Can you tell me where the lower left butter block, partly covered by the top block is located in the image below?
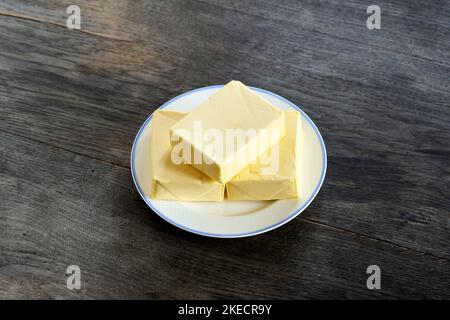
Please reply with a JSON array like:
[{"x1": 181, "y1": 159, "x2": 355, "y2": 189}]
[{"x1": 149, "y1": 110, "x2": 225, "y2": 201}]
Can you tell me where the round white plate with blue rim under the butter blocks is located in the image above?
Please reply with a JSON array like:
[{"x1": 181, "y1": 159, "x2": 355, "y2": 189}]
[{"x1": 131, "y1": 85, "x2": 327, "y2": 238}]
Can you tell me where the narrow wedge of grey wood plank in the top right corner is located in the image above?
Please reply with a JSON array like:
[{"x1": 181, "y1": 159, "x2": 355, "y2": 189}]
[{"x1": 202, "y1": 0, "x2": 450, "y2": 65}]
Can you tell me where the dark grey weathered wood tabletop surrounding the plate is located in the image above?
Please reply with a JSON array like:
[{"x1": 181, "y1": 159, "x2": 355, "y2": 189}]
[{"x1": 0, "y1": 0, "x2": 450, "y2": 299}]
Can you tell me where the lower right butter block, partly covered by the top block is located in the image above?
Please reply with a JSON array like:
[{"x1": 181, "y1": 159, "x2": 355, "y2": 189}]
[{"x1": 226, "y1": 111, "x2": 301, "y2": 200}]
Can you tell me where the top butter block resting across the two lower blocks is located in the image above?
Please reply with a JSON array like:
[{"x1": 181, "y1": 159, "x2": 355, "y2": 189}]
[{"x1": 171, "y1": 81, "x2": 284, "y2": 183}]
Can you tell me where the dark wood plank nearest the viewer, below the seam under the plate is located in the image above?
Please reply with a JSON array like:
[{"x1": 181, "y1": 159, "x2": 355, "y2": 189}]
[{"x1": 0, "y1": 133, "x2": 450, "y2": 299}]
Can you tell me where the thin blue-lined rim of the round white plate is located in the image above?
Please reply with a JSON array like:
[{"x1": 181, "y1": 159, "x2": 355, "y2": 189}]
[{"x1": 130, "y1": 85, "x2": 327, "y2": 238}]
